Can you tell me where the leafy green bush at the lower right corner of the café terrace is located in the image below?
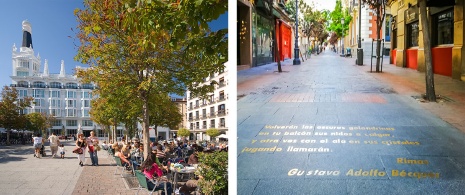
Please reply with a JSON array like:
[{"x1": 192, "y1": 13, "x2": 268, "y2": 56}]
[{"x1": 198, "y1": 151, "x2": 228, "y2": 195}]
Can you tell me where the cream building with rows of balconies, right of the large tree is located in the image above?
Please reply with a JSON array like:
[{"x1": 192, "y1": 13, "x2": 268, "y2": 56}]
[{"x1": 186, "y1": 63, "x2": 228, "y2": 140}]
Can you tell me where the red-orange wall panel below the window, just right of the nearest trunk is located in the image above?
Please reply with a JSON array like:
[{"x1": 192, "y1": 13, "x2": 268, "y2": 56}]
[{"x1": 431, "y1": 47, "x2": 452, "y2": 76}]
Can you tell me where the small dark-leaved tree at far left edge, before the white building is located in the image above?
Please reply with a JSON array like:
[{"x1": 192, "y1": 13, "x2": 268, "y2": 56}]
[{"x1": 0, "y1": 86, "x2": 33, "y2": 145}]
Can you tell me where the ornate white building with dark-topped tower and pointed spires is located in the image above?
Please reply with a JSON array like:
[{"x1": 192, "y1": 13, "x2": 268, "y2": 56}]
[{"x1": 10, "y1": 21, "x2": 116, "y2": 137}]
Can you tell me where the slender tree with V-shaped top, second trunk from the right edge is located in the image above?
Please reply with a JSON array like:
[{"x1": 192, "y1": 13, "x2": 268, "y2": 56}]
[{"x1": 362, "y1": 0, "x2": 388, "y2": 72}]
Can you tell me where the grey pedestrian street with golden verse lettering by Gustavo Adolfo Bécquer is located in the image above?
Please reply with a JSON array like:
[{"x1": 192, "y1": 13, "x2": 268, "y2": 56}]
[{"x1": 237, "y1": 51, "x2": 465, "y2": 194}]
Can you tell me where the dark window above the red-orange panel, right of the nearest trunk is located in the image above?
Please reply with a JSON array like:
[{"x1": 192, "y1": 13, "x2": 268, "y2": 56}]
[{"x1": 433, "y1": 9, "x2": 454, "y2": 45}]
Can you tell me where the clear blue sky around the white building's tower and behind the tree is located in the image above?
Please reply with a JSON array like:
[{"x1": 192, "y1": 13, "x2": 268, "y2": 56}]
[{"x1": 0, "y1": 0, "x2": 228, "y2": 88}]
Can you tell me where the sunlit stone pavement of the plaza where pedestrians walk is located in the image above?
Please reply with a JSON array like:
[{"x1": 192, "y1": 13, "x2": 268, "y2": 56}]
[{"x1": 0, "y1": 141, "x2": 136, "y2": 195}]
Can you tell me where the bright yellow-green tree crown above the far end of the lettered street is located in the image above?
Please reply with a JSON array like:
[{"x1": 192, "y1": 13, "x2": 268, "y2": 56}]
[{"x1": 328, "y1": 0, "x2": 352, "y2": 38}]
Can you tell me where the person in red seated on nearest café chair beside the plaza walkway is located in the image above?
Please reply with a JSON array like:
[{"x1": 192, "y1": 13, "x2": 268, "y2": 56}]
[{"x1": 140, "y1": 154, "x2": 173, "y2": 195}]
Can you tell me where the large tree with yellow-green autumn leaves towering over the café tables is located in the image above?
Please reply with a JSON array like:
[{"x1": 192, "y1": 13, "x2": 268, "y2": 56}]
[{"x1": 75, "y1": 0, "x2": 228, "y2": 156}]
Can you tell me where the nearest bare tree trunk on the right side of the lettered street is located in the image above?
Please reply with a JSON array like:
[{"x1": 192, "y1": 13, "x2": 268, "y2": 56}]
[{"x1": 419, "y1": 0, "x2": 436, "y2": 102}]
